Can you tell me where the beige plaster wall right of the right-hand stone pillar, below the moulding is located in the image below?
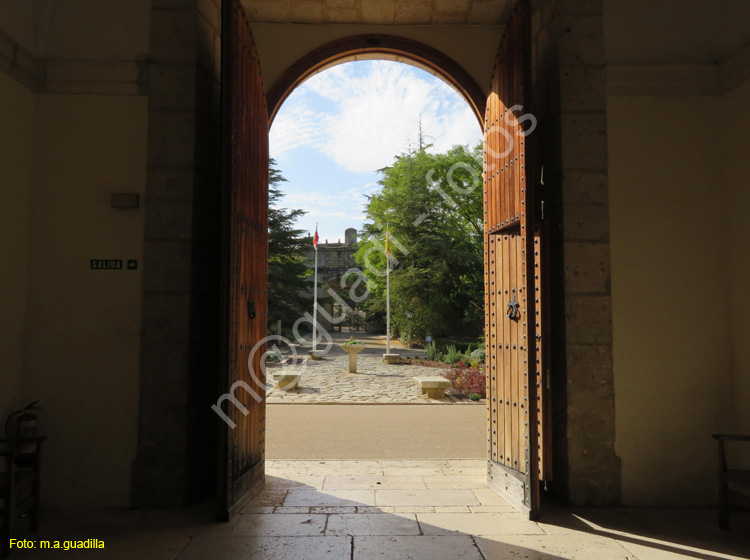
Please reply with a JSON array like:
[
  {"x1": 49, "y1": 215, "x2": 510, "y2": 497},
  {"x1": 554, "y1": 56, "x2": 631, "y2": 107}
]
[{"x1": 608, "y1": 90, "x2": 750, "y2": 505}]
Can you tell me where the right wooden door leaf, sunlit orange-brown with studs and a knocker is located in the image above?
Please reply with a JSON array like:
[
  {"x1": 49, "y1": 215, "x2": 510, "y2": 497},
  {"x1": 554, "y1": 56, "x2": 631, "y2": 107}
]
[{"x1": 484, "y1": 0, "x2": 548, "y2": 518}]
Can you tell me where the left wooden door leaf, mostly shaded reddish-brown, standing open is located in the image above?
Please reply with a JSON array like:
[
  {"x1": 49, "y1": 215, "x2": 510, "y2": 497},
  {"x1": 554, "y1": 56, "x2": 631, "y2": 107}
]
[{"x1": 218, "y1": 0, "x2": 268, "y2": 519}]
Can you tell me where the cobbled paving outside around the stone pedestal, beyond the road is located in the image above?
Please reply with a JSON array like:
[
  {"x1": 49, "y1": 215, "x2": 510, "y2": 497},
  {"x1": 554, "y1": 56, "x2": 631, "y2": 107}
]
[{"x1": 267, "y1": 332, "x2": 476, "y2": 404}]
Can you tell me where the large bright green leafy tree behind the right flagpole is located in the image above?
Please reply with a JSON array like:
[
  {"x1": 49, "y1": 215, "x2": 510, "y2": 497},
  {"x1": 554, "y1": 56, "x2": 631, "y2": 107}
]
[{"x1": 356, "y1": 145, "x2": 484, "y2": 336}]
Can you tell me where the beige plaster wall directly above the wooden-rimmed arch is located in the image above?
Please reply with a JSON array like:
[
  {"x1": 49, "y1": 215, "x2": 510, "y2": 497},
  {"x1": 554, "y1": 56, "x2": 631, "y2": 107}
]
[{"x1": 252, "y1": 23, "x2": 503, "y2": 96}]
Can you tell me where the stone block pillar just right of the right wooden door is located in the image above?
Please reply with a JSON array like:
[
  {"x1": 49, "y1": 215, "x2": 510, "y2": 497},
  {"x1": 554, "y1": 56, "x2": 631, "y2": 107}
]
[{"x1": 531, "y1": 0, "x2": 620, "y2": 505}]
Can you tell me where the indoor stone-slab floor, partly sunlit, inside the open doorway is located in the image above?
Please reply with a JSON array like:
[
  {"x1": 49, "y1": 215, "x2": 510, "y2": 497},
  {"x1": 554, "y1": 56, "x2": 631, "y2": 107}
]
[{"x1": 11, "y1": 460, "x2": 750, "y2": 560}]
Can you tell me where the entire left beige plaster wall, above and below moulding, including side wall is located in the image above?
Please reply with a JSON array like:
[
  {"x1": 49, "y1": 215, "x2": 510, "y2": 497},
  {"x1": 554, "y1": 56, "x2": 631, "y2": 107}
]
[{"x1": 0, "y1": 0, "x2": 152, "y2": 506}]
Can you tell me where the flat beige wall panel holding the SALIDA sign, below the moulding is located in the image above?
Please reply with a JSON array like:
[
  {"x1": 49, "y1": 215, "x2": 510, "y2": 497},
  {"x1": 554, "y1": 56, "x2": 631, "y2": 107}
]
[{"x1": 20, "y1": 95, "x2": 147, "y2": 506}]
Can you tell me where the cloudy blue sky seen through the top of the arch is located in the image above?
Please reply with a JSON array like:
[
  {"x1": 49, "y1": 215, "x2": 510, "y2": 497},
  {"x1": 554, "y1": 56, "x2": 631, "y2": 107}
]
[{"x1": 270, "y1": 60, "x2": 481, "y2": 243}]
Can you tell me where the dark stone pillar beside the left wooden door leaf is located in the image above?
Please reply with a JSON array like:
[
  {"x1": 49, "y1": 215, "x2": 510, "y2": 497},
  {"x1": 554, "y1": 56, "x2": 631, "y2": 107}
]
[{"x1": 133, "y1": 0, "x2": 221, "y2": 506}]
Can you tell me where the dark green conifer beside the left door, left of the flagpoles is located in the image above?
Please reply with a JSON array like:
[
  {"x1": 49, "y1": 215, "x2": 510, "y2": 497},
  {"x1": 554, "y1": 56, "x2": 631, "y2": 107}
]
[{"x1": 268, "y1": 159, "x2": 312, "y2": 328}]
